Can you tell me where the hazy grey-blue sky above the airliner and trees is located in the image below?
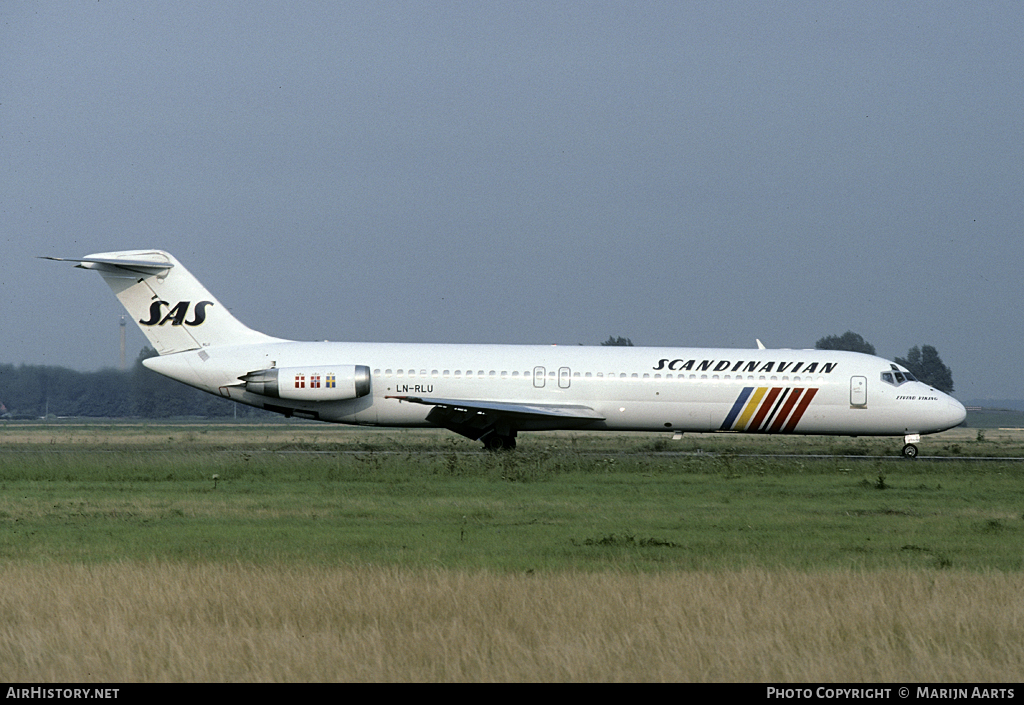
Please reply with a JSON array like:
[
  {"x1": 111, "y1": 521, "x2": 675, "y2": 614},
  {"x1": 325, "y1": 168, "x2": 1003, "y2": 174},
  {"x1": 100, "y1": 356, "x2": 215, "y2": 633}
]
[{"x1": 0, "y1": 0, "x2": 1024, "y2": 399}]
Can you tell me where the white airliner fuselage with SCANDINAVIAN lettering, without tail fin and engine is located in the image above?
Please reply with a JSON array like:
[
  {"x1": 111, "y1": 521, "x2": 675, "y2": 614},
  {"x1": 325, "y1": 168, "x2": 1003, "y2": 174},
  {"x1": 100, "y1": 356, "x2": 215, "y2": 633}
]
[{"x1": 144, "y1": 342, "x2": 965, "y2": 436}]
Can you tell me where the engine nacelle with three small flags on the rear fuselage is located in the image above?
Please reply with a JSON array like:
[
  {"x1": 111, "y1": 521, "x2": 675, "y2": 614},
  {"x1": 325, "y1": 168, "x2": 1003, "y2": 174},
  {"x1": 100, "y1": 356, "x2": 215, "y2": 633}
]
[{"x1": 239, "y1": 365, "x2": 370, "y2": 402}]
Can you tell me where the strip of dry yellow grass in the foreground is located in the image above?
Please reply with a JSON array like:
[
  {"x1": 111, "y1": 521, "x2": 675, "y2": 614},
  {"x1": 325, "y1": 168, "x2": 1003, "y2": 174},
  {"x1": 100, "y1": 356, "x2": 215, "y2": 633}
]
[{"x1": 0, "y1": 564, "x2": 1024, "y2": 682}]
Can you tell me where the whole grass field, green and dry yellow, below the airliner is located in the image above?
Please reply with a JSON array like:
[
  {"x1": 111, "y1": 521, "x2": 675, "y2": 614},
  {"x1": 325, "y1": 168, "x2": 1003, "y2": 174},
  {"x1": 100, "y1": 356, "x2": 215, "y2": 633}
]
[{"x1": 0, "y1": 423, "x2": 1024, "y2": 681}]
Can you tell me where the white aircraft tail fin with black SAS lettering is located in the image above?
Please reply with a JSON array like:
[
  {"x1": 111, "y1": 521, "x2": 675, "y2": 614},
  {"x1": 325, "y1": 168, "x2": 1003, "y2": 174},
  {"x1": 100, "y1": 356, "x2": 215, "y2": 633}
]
[{"x1": 45, "y1": 250, "x2": 276, "y2": 355}]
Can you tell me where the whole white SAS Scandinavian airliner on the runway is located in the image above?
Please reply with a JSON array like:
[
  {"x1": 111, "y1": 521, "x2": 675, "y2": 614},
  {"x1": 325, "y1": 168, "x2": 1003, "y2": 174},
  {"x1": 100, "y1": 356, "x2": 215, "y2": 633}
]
[{"x1": 48, "y1": 250, "x2": 967, "y2": 457}]
